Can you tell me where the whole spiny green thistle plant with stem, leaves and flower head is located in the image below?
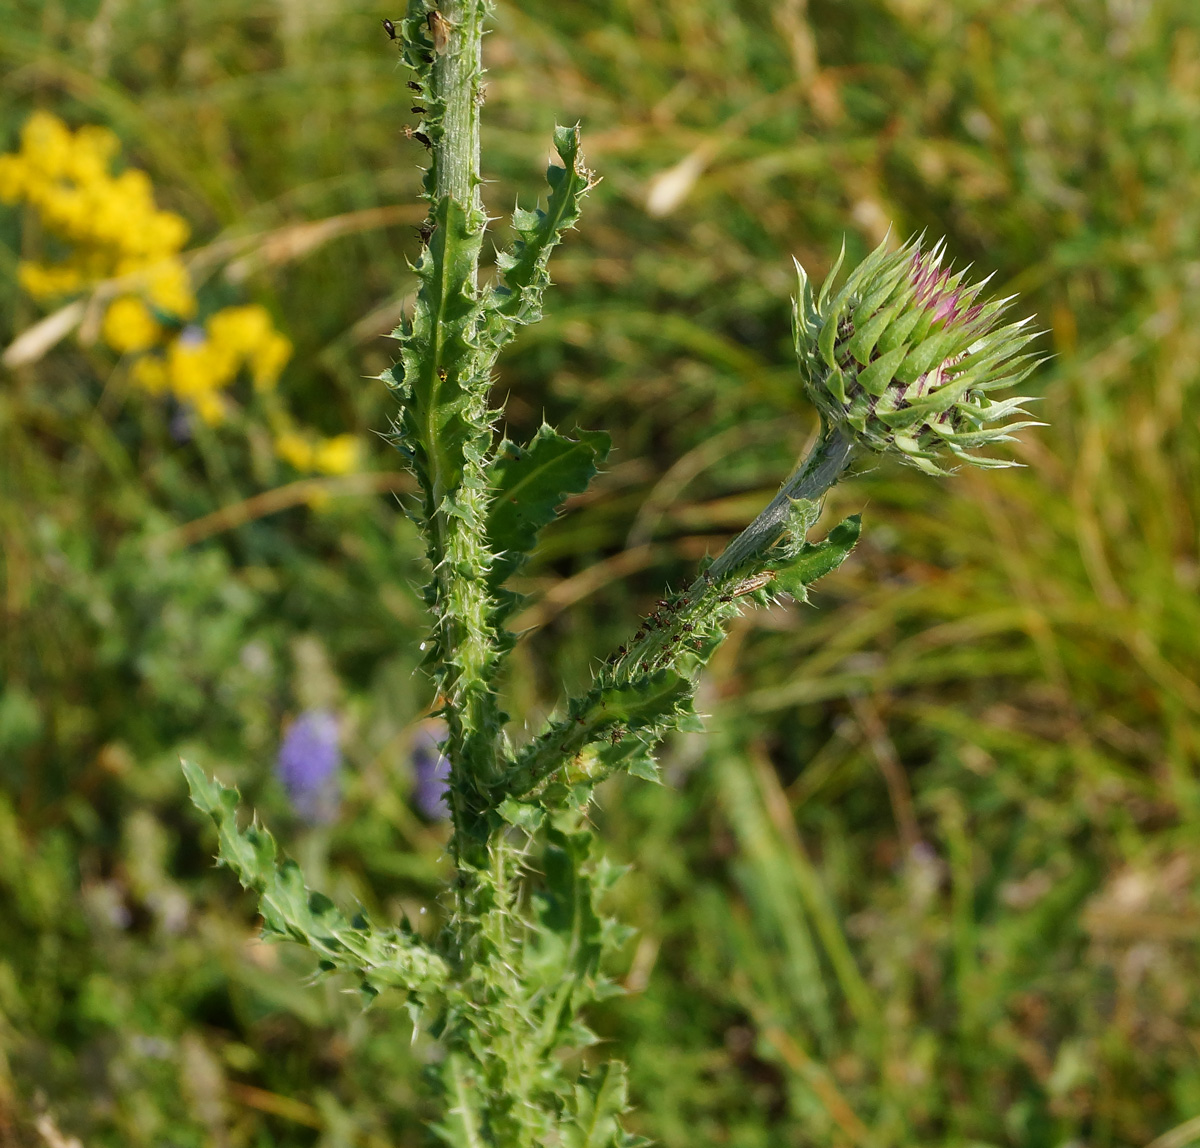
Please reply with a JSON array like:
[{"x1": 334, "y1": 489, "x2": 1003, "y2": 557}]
[{"x1": 185, "y1": 0, "x2": 1034, "y2": 1148}]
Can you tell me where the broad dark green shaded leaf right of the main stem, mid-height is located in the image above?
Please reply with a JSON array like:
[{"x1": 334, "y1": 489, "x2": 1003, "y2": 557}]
[{"x1": 487, "y1": 423, "x2": 612, "y2": 587}]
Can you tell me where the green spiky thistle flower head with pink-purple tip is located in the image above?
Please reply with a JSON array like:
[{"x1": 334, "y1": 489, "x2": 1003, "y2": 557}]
[{"x1": 793, "y1": 239, "x2": 1040, "y2": 474}]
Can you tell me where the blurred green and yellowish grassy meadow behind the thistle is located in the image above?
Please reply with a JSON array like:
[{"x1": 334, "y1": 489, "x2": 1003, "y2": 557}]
[{"x1": 0, "y1": 0, "x2": 1200, "y2": 1148}]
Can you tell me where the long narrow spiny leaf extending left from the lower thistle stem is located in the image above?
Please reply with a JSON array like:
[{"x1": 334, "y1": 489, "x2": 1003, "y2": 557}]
[{"x1": 182, "y1": 762, "x2": 449, "y2": 998}]
